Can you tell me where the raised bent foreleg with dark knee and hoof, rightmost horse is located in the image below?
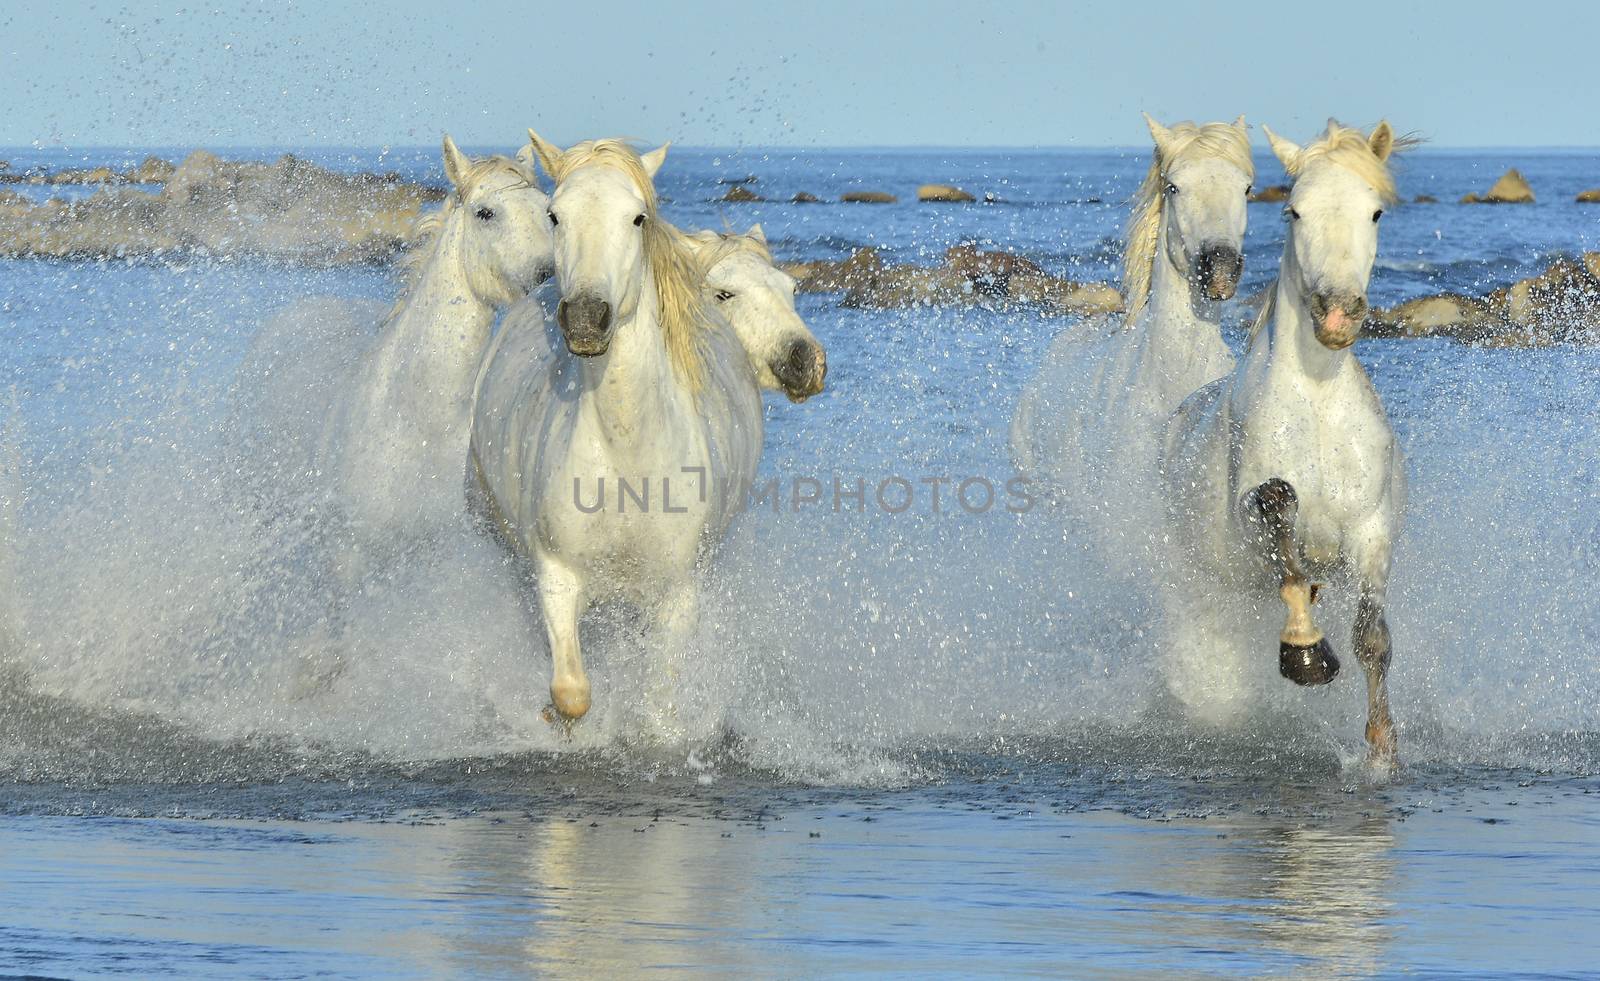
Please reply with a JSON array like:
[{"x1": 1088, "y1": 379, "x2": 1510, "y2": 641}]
[{"x1": 1245, "y1": 477, "x2": 1339, "y2": 685}]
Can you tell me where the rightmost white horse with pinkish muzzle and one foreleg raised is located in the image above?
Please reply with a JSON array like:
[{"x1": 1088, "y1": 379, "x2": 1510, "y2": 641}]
[{"x1": 1165, "y1": 120, "x2": 1405, "y2": 765}]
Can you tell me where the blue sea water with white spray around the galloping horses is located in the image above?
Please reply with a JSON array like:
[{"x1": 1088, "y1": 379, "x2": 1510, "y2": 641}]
[{"x1": 0, "y1": 146, "x2": 1600, "y2": 978}]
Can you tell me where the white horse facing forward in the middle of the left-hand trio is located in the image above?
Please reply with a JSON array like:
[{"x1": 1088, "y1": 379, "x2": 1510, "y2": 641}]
[{"x1": 472, "y1": 131, "x2": 763, "y2": 720}]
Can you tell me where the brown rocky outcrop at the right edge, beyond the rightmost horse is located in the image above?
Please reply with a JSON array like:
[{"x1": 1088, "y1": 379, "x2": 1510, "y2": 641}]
[{"x1": 1368, "y1": 253, "x2": 1600, "y2": 347}]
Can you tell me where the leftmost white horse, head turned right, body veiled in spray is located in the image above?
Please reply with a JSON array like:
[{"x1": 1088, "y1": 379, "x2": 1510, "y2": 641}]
[{"x1": 323, "y1": 136, "x2": 554, "y2": 528}]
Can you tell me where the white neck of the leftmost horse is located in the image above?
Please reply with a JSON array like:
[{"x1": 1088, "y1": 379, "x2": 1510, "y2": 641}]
[{"x1": 387, "y1": 214, "x2": 494, "y2": 384}]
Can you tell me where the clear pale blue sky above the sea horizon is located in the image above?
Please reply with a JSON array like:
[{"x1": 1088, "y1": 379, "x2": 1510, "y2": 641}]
[{"x1": 0, "y1": 0, "x2": 1600, "y2": 147}]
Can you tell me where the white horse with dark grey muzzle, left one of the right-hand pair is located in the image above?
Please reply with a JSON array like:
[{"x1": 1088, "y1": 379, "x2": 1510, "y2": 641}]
[{"x1": 1011, "y1": 115, "x2": 1254, "y2": 554}]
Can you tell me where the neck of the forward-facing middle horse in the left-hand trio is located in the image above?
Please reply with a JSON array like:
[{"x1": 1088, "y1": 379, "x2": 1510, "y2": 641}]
[{"x1": 579, "y1": 262, "x2": 682, "y2": 445}]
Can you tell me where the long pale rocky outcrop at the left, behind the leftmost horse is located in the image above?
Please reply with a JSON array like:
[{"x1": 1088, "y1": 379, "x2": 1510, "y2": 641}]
[{"x1": 0, "y1": 150, "x2": 443, "y2": 264}]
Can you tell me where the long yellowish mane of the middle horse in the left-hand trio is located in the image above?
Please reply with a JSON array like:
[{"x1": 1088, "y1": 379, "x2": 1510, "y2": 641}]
[{"x1": 547, "y1": 139, "x2": 710, "y2": 392}]
